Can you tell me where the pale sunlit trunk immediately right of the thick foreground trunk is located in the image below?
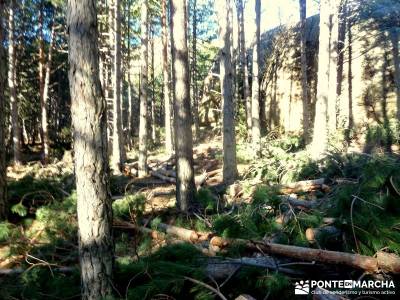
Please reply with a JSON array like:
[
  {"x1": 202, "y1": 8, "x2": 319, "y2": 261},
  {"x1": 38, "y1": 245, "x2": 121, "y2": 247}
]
[{"x1": 111, "y1": 0, "x2": 126, "y2": 173}]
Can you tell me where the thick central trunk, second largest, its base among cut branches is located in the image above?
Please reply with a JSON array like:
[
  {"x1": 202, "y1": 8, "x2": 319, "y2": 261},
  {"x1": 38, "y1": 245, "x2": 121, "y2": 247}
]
[{"x1": 170, "y1": 0, "x2": 196, "y2": 211}]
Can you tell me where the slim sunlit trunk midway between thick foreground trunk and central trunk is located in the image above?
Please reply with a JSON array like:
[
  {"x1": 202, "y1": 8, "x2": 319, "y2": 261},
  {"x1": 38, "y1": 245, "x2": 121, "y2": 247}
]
[{"x1": 139, "y1": 0, "x2": 149, "y2": 177}]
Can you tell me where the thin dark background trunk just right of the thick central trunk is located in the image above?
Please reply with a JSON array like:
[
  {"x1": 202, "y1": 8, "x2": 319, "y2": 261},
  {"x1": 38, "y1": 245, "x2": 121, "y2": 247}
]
[{"x1": 190, "y1": 0, "x2": 200, "y2": 140}]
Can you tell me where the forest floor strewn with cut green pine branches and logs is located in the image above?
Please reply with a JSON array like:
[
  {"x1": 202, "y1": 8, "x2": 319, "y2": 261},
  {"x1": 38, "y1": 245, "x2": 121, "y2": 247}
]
[{"x1": 0, "y1": 137, "x2": 400, "y2": 299}]
